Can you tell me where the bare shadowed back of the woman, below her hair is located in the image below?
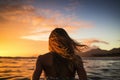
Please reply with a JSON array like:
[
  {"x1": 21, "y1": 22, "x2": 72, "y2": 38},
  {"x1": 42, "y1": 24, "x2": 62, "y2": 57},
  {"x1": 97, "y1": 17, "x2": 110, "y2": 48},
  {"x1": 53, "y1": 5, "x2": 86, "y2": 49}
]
[{"x1": 38, "y1": 52, "x2": 75, "y2": 77}]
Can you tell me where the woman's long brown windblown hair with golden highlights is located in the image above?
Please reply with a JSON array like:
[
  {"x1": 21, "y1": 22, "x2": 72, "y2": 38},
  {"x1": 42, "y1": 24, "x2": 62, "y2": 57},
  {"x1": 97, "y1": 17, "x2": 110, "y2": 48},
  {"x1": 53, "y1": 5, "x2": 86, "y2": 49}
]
[{"x1": 49, "y1": 28, "x2": 84, "y2": 73}]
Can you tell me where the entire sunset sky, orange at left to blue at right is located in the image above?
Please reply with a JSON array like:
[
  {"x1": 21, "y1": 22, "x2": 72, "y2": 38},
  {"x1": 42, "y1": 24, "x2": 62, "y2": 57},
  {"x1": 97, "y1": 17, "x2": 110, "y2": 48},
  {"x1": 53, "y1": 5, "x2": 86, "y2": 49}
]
[{"x1": 0, "y1": 0, "x2": 120, "y2": 57}]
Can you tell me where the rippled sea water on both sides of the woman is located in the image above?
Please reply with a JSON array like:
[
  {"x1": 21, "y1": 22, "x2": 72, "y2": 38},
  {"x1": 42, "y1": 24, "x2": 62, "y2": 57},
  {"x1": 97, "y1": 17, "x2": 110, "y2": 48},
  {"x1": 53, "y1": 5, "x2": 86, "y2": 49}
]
[{"x1": 0, "y1": 57, "x2": 120, "y2": 80}]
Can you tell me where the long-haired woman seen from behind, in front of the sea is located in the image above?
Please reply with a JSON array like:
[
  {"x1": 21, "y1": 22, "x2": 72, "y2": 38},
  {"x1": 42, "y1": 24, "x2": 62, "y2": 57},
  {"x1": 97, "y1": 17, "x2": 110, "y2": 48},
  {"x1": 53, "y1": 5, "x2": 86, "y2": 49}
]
[{"x1": 32, "y1": 28, "x2": 87, "y2": 80}]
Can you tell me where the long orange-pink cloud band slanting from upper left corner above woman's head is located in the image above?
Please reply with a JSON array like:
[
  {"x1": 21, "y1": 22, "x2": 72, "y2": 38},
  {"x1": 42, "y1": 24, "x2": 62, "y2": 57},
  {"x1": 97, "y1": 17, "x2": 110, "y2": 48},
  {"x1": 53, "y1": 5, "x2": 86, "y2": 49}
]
[{"x1": 0, "y1": 0, "x2": 93, "y2": 30}]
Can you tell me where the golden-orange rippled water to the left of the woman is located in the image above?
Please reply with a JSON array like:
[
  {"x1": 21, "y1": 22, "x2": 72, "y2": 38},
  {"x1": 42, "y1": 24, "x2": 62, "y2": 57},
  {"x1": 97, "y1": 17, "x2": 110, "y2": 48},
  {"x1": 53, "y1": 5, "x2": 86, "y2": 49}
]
[{"x1": 0, "y1": 59, "x2": 35, "y2": 79}]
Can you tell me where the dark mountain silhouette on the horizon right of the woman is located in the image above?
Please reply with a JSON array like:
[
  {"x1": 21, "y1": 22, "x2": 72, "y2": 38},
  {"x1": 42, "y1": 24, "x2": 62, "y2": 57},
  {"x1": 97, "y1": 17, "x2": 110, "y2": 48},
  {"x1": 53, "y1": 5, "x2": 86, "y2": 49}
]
[{"x1": 79, "y1": 48, "x2": 120, "y2": 57}]
